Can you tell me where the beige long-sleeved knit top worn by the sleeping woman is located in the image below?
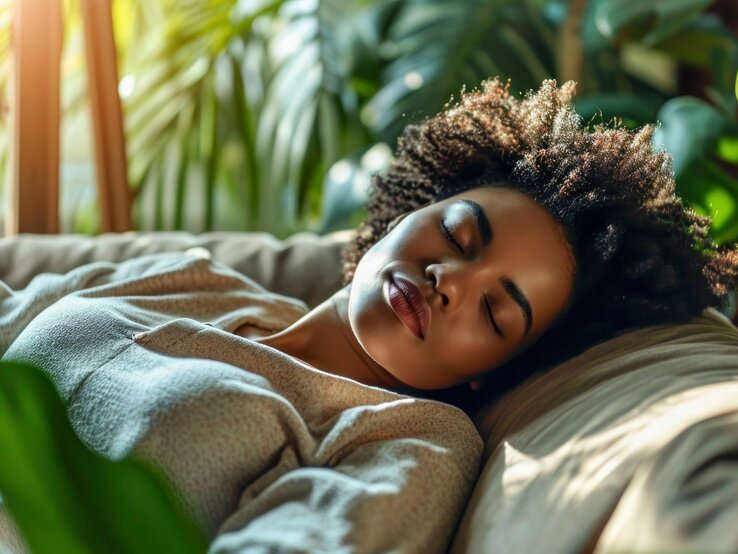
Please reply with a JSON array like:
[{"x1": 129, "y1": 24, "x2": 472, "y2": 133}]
[{"x1": 0, "y1": 249, "x2": 483, "y2": 553}]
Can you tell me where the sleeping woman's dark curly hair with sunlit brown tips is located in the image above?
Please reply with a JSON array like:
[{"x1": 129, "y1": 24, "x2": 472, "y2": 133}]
[{"x1": 343, "y1": 79, "x2": 738, "y2": 409}]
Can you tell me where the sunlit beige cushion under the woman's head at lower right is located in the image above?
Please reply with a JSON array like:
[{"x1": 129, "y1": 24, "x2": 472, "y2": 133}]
[{"x1": 452, "y1": 310, "x2": 738, "y2": 554}]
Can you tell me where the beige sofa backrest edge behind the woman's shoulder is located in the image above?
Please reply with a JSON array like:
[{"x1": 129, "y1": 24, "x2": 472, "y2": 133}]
[{"x1": 0, "y1": 230, "x2": 353, "y2": 308}]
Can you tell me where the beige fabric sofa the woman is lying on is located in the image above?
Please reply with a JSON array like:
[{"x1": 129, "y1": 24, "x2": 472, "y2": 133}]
[{"x1": 0, "y1": 231, "x2": 738, "y2": 554}]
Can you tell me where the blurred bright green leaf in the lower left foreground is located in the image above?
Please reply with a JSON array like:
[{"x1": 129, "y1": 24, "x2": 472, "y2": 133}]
[{"x1": 0, "y1": 363, "x2": 207, "y2": 554}]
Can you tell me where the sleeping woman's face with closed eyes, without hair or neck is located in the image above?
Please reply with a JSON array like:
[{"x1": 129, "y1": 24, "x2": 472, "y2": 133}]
[{"x1": 348, "y1": 187, "x2": 574, "y2": 389}]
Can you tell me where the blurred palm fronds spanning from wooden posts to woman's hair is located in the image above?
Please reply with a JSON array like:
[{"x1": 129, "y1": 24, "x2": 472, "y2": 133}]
[{"x1": 118, "y1": 0, "x2": 371, "y2": 236}]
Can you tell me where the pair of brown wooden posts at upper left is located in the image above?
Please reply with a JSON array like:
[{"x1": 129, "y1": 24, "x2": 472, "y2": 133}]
[{"x1": 5, "y1": 0, "x2": 132, "y2": 235}]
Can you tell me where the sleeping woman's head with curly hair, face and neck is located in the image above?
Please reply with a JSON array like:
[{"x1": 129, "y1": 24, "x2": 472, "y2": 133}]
[{"x1": 237, "y1": 80, "x2": 738, "y2": 411}]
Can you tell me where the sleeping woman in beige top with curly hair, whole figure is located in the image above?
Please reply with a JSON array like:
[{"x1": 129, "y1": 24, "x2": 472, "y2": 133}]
[{"x1": 0, "y1": 80, "x2": 738, "y2": 552}]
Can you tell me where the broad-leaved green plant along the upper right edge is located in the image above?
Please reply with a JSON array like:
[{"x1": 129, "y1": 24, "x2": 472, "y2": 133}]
[{"x1": 595, "y1": 0, "x2": 738, "y2": 243}]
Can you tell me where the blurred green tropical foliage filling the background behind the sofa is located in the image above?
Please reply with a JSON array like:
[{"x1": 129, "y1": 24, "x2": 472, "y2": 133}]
[{"x1": 0, "y1": 0, "x2": 738, "y2": 241}]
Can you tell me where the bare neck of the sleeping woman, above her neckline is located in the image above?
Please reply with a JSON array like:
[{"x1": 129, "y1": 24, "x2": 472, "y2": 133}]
[{"x1": 256, "y1": 285, "x2": 407, "y2": 389}]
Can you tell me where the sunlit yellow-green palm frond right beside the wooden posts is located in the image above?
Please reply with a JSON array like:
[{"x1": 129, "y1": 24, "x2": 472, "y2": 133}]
[{"x1": 123, "y1": 0, "x2": 285, "y2": 230}]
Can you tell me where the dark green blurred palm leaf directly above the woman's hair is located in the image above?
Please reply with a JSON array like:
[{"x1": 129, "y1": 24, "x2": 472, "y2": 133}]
[{"x1": 363, "y1": 0, "x2": 555, "y2": 142}]
